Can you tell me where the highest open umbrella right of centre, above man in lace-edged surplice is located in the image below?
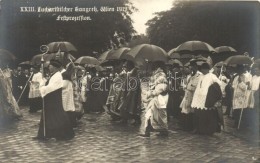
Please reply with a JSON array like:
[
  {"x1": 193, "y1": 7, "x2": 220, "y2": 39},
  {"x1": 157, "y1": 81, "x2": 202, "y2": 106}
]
[{"x1": 175, "y1": 41, "x2": 216, "y2": 54}]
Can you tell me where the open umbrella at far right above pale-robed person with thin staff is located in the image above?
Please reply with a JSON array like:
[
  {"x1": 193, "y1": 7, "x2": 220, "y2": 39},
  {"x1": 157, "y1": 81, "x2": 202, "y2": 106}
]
[{"x1": 224, "y1": 55, "x2": 253, "y2": 65}]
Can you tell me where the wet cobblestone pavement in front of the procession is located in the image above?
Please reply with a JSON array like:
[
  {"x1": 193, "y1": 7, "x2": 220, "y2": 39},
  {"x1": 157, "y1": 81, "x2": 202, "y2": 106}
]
[{"x1": 0, "y1": 108, "x2": 260, "y2": 163}]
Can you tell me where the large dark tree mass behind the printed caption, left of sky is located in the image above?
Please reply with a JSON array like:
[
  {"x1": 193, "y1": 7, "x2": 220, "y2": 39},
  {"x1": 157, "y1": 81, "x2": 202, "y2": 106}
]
[{"x1": 0, "y1": 0, "x2": 136, "y2": 61}]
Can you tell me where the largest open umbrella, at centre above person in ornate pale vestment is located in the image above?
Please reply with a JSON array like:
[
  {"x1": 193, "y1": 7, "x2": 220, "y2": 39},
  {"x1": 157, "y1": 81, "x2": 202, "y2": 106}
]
[{"x1": 123, "y1": 44, "x2": 168, "y2": 65}]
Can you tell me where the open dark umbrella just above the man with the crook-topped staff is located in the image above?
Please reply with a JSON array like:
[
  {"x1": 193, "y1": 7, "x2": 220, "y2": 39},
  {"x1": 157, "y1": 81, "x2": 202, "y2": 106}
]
[{"x1": 47, "y1": 41, "x2": 77, "y2": 53}]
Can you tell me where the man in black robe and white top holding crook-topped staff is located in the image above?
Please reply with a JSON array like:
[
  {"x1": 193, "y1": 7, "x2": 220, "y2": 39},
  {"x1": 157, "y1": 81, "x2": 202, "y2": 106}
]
[{"x1": 36, "y1": 60, "x2": 74, "y2": 140}]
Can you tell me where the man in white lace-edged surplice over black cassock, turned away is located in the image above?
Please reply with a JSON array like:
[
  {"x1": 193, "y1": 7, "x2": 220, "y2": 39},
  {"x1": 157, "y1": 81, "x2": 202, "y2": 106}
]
[{"x1": 191, "y1": 63, "x2": 222, "y2": 135}]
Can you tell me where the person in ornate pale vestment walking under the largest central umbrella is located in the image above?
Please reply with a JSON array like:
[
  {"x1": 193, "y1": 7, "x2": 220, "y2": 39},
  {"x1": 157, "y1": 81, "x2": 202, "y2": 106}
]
[{"x1": 139, "y1": 61, "x2": 169, "y2": 137}]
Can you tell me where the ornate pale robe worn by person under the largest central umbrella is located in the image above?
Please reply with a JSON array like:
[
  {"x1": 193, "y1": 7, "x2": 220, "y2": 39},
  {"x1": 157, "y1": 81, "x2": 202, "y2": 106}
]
[{"x1": 140, "y1": 68, "x2": 169, "y2": 134}]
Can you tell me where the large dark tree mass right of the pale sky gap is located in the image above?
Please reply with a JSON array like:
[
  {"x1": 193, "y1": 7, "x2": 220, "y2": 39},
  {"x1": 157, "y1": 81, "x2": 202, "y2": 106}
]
[{"x1": 147, "y1": 1, "x2": 260, "y2": 58}]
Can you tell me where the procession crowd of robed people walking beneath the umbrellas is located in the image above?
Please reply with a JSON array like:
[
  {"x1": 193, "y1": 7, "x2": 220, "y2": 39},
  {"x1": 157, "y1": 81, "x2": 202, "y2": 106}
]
[{"x1": 0, "y1": 53, "x2": 260, "y2": 140}]
